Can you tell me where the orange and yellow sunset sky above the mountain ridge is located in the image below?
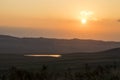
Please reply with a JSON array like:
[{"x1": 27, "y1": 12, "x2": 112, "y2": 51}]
[{"x1": 0, "y1": 0, "x2": 120, "y2": 41}]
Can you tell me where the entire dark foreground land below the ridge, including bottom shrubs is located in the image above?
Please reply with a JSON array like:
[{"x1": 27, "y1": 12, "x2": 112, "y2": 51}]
[{"x1": 0, "y1": 48, "x2": 120, "y2": 80}]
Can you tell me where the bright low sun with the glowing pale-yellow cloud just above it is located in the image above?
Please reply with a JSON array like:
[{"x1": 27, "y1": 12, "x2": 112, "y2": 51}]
[{"x1": 80, "y1": 11, "x2": 93, "y2": 24}]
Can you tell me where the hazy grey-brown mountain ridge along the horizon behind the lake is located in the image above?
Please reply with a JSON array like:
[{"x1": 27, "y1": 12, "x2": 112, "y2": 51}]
[{"x1": 0, "y1": 35, "x2": 120, "y2": 54}]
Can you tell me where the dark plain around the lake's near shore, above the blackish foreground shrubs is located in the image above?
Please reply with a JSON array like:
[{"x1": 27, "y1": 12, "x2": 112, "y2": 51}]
[{"x1": 0, "y1": 48, "x2": 120, "y2": 70}]
